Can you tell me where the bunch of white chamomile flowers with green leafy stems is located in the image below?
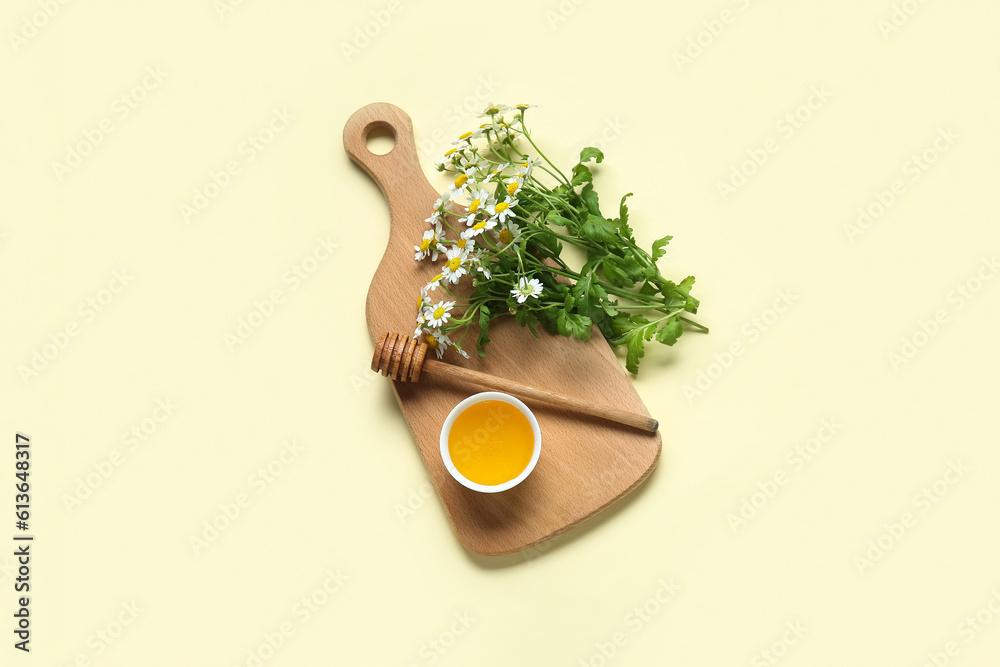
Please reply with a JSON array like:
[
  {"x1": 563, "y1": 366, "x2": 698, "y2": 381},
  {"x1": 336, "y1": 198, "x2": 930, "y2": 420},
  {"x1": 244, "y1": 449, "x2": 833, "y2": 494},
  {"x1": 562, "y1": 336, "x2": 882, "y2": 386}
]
[{"x1": 414, "y1": 104, "x2": 708, "y2": 373}]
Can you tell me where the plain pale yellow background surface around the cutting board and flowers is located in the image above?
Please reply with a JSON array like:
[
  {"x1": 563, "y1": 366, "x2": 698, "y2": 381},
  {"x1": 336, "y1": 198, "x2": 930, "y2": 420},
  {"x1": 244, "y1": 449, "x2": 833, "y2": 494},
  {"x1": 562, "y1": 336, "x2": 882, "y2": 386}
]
[{"x1": 0, "y1": 0, "x2": 1000, "y2": 666}]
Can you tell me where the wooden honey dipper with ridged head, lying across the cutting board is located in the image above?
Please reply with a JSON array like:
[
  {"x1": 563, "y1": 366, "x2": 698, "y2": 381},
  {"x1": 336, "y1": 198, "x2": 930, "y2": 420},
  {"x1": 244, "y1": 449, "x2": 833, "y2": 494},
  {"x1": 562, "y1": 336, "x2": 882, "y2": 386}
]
[{"x1": 372, "y1": 333, "x2": 660, "y2": 433}]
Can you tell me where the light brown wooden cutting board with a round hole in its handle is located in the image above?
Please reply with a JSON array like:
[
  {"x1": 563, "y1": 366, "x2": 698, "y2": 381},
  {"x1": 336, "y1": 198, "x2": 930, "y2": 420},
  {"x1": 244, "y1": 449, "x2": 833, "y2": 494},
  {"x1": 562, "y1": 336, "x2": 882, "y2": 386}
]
[{"x1": 344, "y1": 103, "x2": 660, "y2": 555}]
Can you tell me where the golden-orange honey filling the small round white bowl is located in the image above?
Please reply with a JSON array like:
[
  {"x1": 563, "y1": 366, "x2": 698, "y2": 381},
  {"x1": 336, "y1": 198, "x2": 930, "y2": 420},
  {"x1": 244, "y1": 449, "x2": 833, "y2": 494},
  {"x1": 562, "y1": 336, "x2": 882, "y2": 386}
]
[{"x1": 448, "y1": 400, "x2": 535, "y2": 486}]
